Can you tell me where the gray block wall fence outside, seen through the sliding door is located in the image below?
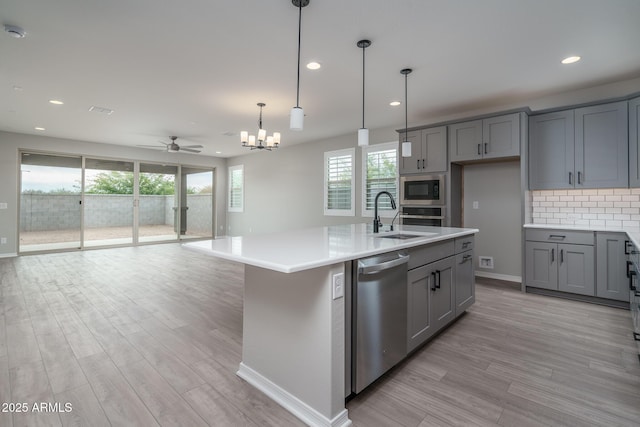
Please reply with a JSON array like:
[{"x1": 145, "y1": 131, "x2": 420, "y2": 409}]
[{"x1": 20, "y1": 194, "x2": 213, "y2": 231}]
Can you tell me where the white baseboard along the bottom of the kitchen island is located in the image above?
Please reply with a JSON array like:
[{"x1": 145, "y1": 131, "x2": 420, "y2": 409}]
[{"x1": 236, "y1": 363, "x2": 351, "y2": 427}]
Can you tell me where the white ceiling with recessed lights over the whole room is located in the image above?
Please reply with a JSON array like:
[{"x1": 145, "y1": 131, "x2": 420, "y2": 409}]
[{"x1": 0, "y1": 0, "x2": 640, "y2": 157}]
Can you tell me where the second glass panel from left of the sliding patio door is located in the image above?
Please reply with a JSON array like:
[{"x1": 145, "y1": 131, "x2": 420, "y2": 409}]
[{"x1": 84, "y1": 158, "x2": 134, "y2": 247}]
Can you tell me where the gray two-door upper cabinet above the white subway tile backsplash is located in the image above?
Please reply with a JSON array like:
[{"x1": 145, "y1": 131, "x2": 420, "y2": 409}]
[{"x1": 529, "y1": 101, "x2": 629, "y2": 190}]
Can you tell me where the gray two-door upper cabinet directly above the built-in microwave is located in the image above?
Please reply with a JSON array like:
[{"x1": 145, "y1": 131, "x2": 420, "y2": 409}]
[{"x1": 400, "y1": 126, "x2": 447, "y2": 174}]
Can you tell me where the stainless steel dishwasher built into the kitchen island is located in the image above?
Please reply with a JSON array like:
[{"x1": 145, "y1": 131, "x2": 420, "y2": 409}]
[{"x1": 351, "y1": 252, "x2": 409, "y2": 393}]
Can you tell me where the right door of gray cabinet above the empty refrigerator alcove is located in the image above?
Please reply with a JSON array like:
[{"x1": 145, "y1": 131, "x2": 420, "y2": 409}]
[{"x1": 482, "y1": 113, "x2": 520, "y2": 159}]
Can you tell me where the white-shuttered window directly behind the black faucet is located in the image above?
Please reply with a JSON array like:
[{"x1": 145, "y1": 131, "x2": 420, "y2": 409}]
[{"x1": 362, "y1": 142, "x2": 398, "y2": 216}]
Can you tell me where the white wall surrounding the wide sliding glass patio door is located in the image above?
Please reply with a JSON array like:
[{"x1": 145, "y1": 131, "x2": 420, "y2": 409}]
[{"x1": 0, "y1": 132, "x2": 227, "y2": 257}]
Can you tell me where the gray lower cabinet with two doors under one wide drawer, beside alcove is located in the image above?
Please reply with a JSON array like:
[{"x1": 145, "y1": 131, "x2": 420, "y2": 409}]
[{"x1": 525, "y1": 229, "x2": 595, "y2": 296}]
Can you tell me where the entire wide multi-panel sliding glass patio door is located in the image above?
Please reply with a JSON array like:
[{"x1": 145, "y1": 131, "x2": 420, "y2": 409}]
[{"x1": 19, "y1": 152, "x2": 215, "y2": 253}]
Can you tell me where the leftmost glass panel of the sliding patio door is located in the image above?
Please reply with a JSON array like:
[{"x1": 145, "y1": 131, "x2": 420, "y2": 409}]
[{"x1": 18, "y1": 153, "x2": 82, "y2": 252}]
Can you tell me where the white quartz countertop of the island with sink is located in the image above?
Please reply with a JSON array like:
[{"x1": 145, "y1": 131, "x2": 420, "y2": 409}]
[{"x1": 183, "y1": 224, "x2": 479, "y2": 273}]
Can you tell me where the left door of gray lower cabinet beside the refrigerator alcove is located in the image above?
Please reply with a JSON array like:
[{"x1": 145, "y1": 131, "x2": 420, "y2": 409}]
[{"x1": 525, "y1": 241, "x2": 558, "y2": 291}]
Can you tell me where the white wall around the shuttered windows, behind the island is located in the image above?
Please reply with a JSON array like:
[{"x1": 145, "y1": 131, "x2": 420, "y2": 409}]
[{"x1": 222, "y1": 128, "x2": 398, "y2": 236}]
